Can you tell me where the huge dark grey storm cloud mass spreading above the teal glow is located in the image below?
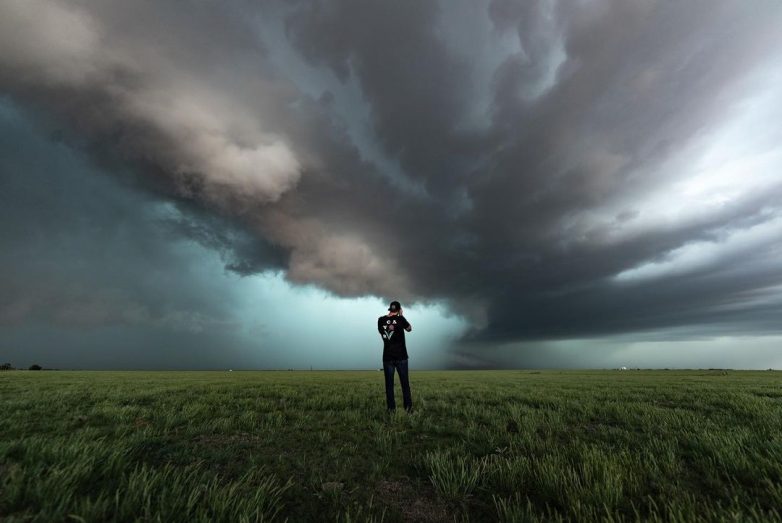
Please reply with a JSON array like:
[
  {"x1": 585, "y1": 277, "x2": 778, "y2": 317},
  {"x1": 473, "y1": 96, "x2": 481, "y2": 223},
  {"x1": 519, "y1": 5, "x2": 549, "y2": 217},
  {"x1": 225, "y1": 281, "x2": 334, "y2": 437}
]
[{"x1": 0, "y1": 0, "x2": 782, "y2": 356}]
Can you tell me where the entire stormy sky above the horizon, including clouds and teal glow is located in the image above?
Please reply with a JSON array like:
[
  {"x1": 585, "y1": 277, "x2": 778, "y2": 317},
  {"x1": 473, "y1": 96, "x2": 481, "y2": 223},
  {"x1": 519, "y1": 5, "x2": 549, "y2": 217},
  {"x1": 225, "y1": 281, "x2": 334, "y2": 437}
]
[{"x1": 0, "y1": 0, "x2": 782, "y2": 368}]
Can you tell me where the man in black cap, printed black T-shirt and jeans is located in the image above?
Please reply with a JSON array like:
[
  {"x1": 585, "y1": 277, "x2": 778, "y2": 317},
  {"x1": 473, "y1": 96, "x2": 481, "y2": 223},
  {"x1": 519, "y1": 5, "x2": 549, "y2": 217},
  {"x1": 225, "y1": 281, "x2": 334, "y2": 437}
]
[{"x1": 377, "y1": 301, "x2": 413, "y2": 412}]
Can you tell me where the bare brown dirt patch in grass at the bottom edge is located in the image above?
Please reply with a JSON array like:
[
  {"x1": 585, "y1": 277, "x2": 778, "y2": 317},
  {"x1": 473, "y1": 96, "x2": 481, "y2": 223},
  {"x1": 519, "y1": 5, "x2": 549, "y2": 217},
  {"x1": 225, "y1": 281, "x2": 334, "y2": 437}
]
[{"x1": 375, "y1": 481, "x2": 452, "y2": 523}]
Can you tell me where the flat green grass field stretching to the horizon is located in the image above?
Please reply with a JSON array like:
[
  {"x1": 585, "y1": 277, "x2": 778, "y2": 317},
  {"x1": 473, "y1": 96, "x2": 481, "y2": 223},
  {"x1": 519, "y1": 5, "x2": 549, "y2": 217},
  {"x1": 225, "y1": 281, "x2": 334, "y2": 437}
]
[{"x1": 0, "y1": 370, "x2": 782, "y2": 522}]
